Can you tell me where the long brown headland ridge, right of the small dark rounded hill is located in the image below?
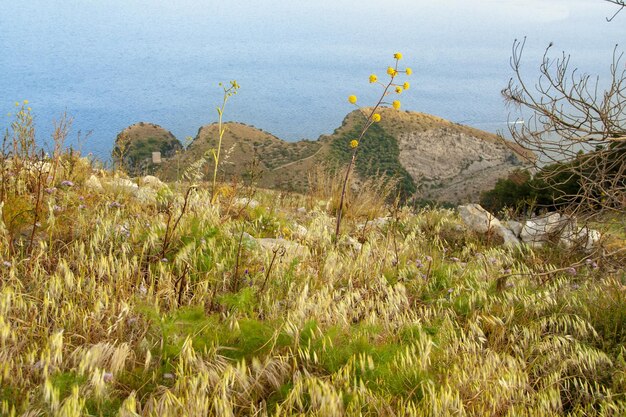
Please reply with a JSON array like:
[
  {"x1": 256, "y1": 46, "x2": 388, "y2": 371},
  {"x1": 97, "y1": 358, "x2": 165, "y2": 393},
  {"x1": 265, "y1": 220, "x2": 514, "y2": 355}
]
[{"x1": 114, "y1": 108, "x2": 533, "y2": 203}]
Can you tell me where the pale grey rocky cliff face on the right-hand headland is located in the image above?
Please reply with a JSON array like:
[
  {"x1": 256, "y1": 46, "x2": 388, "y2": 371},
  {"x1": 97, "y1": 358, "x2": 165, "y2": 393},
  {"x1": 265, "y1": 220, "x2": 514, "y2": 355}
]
[{"x1": 397, "y1": 126, "x2": 523, "y2": 203}]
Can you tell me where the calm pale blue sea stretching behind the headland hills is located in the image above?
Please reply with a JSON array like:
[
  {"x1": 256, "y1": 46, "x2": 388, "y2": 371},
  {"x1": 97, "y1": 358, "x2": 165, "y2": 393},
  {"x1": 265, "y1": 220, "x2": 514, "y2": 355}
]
[{"x1": 0, "y1": 0, "x2": 626, "y2": 159}]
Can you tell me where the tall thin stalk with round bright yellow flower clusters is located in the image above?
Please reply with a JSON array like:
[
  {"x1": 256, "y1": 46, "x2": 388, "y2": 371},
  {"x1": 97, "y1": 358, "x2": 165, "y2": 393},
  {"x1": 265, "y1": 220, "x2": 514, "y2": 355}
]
[{"x1": 335, "y1": 52, "x2": 412, "y2": 241}]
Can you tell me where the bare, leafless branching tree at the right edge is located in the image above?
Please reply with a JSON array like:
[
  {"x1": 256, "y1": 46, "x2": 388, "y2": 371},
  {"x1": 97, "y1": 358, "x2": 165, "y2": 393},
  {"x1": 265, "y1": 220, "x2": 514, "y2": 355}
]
[{"x1": 502, "y1": 29, "x2": 626, "y2": 213}]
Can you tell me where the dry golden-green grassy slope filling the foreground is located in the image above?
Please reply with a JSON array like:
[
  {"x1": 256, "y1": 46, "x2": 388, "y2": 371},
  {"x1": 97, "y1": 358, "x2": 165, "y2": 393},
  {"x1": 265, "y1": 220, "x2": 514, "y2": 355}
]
[{"x1": 0, "y1": 154, "x2": 626, "y2": 417}]
